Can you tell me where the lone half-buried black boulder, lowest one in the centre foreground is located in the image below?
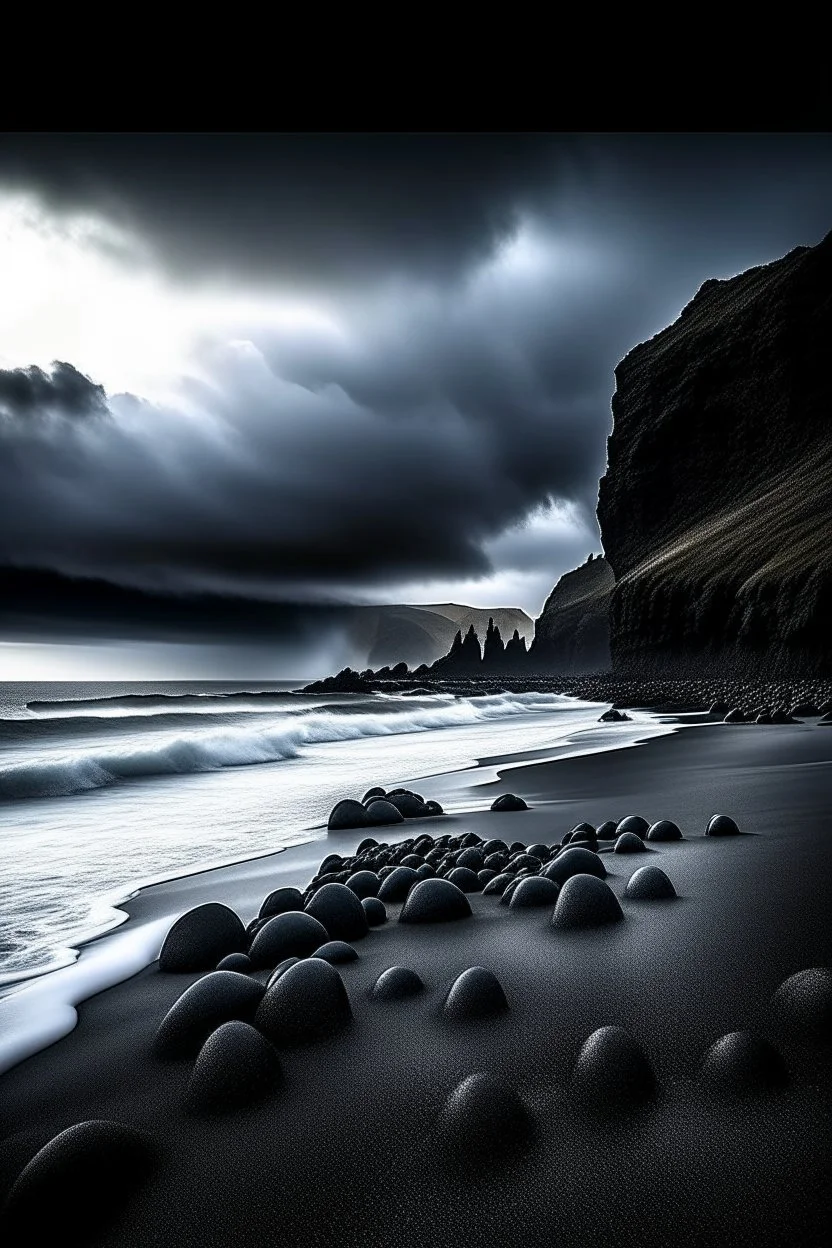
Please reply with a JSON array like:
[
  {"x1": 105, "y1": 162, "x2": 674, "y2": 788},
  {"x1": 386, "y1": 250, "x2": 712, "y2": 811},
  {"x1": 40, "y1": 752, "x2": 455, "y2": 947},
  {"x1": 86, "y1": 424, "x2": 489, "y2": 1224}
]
[{"x1": 437, "y1": 1072, "x2": 534, "y2": 1164}]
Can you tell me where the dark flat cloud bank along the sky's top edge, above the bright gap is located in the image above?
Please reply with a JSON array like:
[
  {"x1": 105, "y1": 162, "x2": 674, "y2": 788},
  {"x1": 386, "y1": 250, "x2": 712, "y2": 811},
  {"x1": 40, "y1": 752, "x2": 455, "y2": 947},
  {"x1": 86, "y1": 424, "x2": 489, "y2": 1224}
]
[{"x1": 0, "y1": 134, "x2": 580, "y2": 286}]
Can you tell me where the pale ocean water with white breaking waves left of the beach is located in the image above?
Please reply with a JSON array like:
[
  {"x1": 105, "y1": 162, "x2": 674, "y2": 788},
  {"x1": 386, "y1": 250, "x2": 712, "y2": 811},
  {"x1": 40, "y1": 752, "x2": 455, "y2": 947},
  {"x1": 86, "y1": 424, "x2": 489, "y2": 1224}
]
[{"x1": 0, "y1": 681, "x2": 667, "y2": 991}]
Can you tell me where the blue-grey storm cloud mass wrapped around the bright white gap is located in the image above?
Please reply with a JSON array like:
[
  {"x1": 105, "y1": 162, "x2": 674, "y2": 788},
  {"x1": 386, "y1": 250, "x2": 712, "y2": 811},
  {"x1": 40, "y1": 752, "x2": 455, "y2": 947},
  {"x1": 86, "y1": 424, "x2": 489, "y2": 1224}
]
[{"x1": 0, "y1": 135, "x2": 832, "y2": 635}]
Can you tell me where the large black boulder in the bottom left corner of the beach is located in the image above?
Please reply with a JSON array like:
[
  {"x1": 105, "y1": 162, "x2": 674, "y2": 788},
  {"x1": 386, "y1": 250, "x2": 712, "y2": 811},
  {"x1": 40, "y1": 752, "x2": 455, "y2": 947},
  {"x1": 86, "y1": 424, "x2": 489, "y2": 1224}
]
[{"x1": 2, "y1": 1119, "x2": 156, "y2": 1246}]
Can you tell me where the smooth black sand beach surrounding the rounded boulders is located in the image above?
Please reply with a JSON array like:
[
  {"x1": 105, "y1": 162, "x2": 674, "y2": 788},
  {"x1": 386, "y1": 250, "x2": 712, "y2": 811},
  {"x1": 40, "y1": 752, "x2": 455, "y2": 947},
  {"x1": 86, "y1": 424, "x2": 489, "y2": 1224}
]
[{"x1": 0, "y1": 723, "x2": 832, "y2": 1248}]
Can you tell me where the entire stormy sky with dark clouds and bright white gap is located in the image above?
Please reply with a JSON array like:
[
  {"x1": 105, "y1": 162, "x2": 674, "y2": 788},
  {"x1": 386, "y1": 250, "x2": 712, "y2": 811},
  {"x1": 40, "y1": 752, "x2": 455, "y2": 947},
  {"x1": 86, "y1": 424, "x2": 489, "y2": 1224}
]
[{"x1": 0, "y1": 134, "x2": 832, "y2": 679}]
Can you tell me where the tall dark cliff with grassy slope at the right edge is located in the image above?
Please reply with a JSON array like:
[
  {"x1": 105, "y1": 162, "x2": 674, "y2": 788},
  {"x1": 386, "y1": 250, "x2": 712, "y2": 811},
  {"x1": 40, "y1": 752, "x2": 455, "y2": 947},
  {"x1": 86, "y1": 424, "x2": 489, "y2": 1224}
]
[{"x1": 597, "y1": 235, "x2": 832, "y2": 678}]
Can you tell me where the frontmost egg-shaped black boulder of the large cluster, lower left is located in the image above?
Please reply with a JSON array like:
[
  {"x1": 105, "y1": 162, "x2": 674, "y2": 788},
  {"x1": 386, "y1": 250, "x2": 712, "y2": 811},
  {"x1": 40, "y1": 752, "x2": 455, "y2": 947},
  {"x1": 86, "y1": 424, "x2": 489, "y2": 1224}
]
[{"x1": 185, "y1": 1022, "x2": 282, "y2": 1113}]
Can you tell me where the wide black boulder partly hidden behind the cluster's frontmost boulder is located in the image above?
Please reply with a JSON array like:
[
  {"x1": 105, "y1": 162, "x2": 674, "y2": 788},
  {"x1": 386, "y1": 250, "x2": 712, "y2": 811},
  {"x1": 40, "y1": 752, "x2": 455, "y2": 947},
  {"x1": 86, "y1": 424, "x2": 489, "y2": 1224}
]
[{"x1": 153, "y1": 971, "x2": 264, "y2": 1057}]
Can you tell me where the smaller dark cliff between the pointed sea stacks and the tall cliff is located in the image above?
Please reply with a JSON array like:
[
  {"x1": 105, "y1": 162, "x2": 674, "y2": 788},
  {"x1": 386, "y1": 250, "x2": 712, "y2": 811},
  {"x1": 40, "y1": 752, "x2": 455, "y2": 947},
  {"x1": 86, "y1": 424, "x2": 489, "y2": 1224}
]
[{"x1": 530, "y1": 557, "x2": 614, "y2": 673}]
